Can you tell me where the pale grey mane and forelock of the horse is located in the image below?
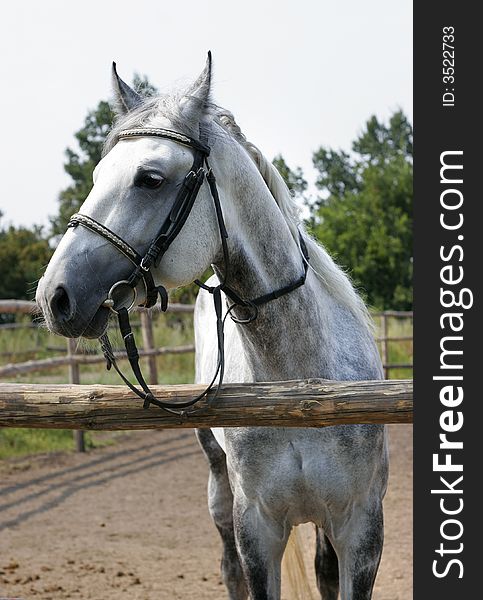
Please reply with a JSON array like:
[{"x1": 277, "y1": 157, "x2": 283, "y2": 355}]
[{"x1": 103, "y1": 94, "x2": 374, "y2": 332}]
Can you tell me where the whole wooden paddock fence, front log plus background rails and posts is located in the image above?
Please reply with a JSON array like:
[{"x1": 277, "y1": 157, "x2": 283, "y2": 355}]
[{"x1": 0, "y1": 300, "x2": 413, "y2": 452}]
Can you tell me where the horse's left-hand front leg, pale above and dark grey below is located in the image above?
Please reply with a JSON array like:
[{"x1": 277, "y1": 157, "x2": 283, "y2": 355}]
[{"x1": 233, "y1": 492, "x2": 290, "y2": 600}]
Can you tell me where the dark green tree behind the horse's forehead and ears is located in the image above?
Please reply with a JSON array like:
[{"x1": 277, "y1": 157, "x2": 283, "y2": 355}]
[{"x1": 50, "y1": 74, "x2": 156, "y2": 236}]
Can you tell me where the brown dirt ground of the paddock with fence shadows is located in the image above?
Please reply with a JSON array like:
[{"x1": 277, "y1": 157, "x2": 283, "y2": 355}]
[{"x1": 0, "y1": 425, "x2": 412, "y2": 600}]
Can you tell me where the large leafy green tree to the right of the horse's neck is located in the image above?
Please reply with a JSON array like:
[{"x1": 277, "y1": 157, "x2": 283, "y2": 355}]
[{"x1": 311, "y1": 111, "x2": 413, "y2": 310}]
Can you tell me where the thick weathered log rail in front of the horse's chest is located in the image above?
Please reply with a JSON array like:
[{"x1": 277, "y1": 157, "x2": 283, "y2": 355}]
[{"x1": 0, "y1": 379, "x2": 413, "y2": 430}]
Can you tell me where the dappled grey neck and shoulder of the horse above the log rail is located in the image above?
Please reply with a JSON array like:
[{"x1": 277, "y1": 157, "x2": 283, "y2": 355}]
[{"x1": 210, "y1": 134, "x2": 381, "y2": 381}]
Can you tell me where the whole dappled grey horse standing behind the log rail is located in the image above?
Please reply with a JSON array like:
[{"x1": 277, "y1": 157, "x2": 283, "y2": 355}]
[{"x1": 37, "y1": 57, "x2": 388, "y2": 600}]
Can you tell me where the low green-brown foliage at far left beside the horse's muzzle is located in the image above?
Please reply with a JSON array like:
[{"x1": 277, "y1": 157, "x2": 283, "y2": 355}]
[{"x1": 0, "y1": 213, "x2": 52, "y2": 300}]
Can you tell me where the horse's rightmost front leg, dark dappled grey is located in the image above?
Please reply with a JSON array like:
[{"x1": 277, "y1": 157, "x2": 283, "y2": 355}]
[{"x1": 334, "y1": 502, "x2": 384, "y2": 600}]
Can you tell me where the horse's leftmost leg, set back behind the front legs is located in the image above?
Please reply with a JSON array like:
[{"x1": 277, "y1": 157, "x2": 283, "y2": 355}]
[{"x1": 196, "y1": 429, "x2": 248, "y2": 600}]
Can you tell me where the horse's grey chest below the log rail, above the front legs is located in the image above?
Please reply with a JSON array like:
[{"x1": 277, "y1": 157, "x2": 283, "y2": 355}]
[{"x1": 218, "y1": 428, "x2": 382, "y2": 525}]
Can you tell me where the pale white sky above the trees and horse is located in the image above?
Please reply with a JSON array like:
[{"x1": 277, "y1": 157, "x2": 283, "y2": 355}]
[{"x1": 0, "y1": 0, "x2": 412, "y2": 230}]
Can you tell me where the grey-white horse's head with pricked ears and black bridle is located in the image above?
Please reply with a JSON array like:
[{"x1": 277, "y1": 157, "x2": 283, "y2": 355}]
[{"x1": 36, "y1": 54, "x2": 221, "y2": 338}]
